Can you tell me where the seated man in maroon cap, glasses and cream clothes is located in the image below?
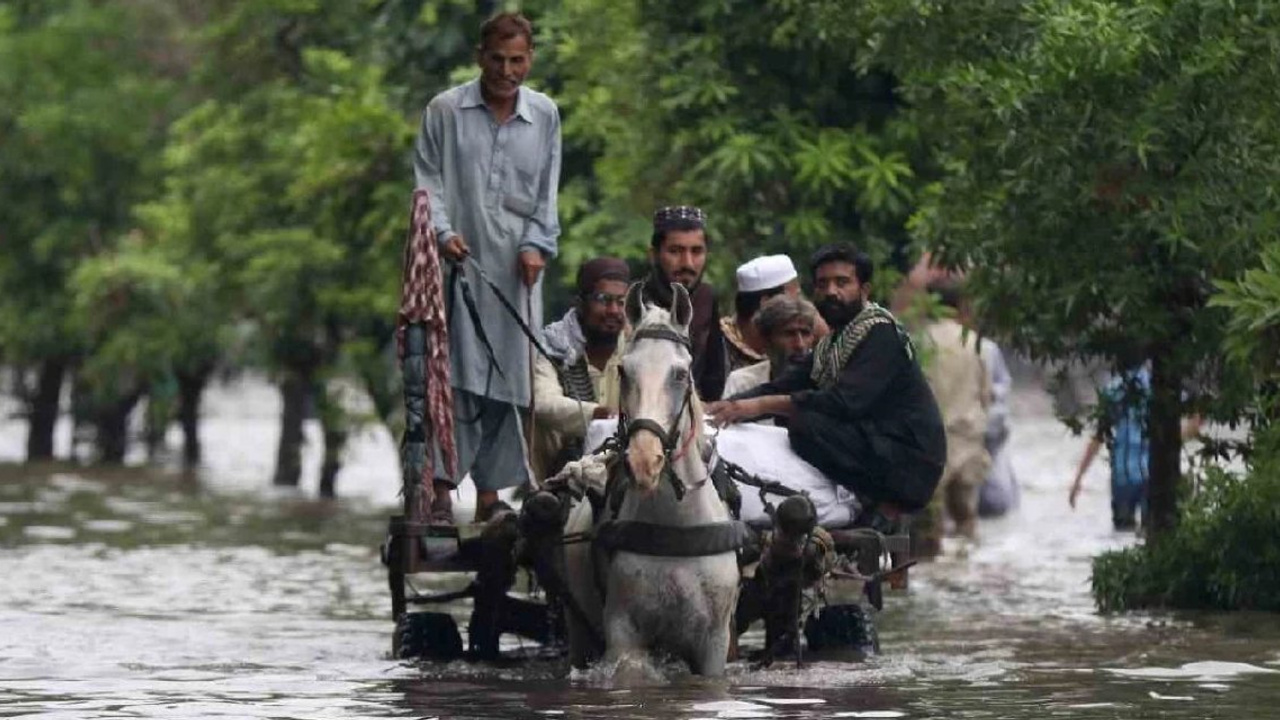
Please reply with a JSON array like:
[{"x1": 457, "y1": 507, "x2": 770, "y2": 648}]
[{"x1": 530, "y1": 258, "x2": 631, "y2": 478}]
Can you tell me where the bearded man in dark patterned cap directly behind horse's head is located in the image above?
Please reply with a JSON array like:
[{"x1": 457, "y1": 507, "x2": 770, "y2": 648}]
[{"x1": 644, "y1": 205, "x2": 728, "y2": 400}]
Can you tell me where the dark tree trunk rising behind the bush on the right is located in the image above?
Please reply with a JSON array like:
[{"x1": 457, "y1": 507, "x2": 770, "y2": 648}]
[{"x1": 1147, "y1": 352, "x2": 1183, "y2": 539}]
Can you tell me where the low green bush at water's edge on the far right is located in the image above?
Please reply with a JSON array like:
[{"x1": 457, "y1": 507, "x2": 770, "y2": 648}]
[{"x1": 1093, "y1": 454, "x2": 1280, "y2": 612}]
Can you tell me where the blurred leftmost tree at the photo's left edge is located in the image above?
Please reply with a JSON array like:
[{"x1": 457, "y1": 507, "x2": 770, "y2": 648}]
[{"x1": 0, "y1": 0, "x2": 185, "y2": 460}]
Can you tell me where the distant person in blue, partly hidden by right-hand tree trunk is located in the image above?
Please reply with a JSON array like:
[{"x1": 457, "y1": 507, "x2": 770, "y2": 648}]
[{"x1": 1069, "y1": 365, "x2": 1201, "y2": 530}]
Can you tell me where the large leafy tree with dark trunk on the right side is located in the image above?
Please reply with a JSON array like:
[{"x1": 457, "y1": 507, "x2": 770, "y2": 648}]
[{"x1": 849, "y1": 0, "x2": 1280, "y2": 537}]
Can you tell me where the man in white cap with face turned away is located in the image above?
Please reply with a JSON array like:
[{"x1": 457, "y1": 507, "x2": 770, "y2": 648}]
[{"x1": 721, "y1": 255, "x2": 800, "y2": 373}]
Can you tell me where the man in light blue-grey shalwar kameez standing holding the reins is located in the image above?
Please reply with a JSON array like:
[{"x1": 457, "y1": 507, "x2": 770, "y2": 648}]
[{"x1": 413, "y1": 13, "x2": 561, "y2": 523}]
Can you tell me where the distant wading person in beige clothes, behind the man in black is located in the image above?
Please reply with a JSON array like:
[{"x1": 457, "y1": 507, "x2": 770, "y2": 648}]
[{"x1": 924, "y1": 281, "x2": 992, "y2": 539}]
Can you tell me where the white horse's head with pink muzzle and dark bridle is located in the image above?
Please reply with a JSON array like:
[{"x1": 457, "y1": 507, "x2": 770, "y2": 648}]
[{"x1": 618, "y1": 283, "x2": 701, "y2": 493}]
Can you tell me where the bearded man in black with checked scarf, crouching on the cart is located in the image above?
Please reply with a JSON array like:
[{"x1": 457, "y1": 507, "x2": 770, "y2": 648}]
[{"x1": 708, "y1": 243, "x2": 947, "y2": 533}]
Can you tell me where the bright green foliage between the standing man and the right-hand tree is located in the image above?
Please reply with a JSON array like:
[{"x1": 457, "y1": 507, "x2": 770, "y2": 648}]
[{"x1": 543, "y1": 0, "x2": 916, "y2": 293}]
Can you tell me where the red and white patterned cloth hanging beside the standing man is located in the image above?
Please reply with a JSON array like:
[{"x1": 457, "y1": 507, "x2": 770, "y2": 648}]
[{"x1": 396, "y1": 190, "x2": 458, "y2": 507}]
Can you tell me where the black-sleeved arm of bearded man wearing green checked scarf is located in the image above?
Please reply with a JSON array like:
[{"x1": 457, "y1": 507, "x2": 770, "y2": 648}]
[{"x1": 791, "y1": 323, "x2": 911, "y2": 420}]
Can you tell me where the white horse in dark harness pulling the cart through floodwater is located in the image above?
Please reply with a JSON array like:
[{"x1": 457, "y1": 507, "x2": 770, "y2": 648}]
[{"x1": 564, "y1": 284, "x2": 741, "y2": 675}]
